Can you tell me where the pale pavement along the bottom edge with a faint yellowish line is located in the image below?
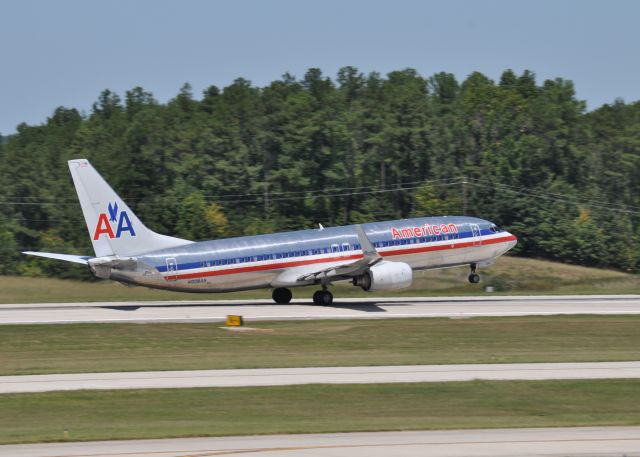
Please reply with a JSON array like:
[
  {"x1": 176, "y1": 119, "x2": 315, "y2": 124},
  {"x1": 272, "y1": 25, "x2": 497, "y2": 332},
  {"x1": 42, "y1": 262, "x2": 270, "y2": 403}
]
[{"x1": 0, "y1": 427, "x2": 640, "y2": 457}]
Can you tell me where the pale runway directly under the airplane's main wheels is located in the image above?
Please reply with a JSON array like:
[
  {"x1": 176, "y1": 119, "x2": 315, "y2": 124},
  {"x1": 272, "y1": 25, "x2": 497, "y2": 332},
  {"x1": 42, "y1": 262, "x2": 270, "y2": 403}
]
[{"x1": 0, "y1": 295, "x2": 640, "y2": 324}]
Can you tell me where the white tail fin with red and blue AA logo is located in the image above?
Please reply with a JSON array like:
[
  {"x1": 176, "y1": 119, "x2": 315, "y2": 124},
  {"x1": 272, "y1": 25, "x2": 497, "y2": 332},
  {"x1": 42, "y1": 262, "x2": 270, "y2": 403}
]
[{"x1": 69, "y1": 159, "x2": 191, "y2": 257}]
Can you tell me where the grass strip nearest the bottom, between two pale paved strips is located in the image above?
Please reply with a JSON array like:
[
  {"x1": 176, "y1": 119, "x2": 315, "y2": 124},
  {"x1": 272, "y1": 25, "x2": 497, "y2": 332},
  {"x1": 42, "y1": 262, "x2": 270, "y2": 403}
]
[{"x1": 0, "y1": 380, "x2": 640, "y2": 444}]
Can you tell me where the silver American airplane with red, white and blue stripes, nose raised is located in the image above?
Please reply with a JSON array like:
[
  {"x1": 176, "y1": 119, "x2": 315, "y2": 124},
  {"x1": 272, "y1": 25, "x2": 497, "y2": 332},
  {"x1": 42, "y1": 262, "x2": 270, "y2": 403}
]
[{"x1": 23, "y1": 159, "x2": 517, "y2": 306}]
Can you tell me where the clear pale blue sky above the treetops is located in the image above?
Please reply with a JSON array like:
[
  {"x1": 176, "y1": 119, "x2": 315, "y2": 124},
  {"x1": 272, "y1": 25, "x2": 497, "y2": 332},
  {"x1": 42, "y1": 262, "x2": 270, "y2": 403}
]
[{"x1": 0, "y1": 0, "x2": 640, "y2": 135}]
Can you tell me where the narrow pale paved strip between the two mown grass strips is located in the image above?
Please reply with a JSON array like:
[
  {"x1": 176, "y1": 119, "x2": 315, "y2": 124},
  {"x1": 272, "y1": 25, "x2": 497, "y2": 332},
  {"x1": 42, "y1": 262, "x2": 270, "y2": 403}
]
[{"x1": 0, "y1": 362, "x2": 640, "y2": 394}]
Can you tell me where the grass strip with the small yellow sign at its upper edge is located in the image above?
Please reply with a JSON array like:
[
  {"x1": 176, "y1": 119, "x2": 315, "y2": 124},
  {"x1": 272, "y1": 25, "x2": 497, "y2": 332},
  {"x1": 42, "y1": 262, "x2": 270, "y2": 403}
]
[{"x1": 0, "y1": 316, "x2": 640, "y2": 375}]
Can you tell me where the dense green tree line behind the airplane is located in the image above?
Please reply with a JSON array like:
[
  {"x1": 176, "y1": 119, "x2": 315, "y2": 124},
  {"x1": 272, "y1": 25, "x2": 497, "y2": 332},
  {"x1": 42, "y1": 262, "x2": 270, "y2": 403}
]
[{"x1": 0, "y1": 67, "x2": 640, "y2": 277}]
